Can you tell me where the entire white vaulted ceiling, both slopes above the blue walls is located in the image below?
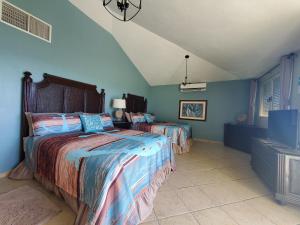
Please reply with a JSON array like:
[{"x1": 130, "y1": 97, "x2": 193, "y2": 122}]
[{"x1": 70, "y1": 0, "x2": 300, "y2": 85}]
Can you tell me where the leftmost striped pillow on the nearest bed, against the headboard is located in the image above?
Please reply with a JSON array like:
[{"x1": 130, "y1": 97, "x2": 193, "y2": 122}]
[{"x1": 26, "y1": 113, "x2": 82, "y2": 136}]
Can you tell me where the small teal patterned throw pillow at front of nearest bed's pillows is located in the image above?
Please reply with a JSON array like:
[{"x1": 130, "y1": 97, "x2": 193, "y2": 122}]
[{"x1": 80, "y1": 114, "x2": 103, "y2": 133}]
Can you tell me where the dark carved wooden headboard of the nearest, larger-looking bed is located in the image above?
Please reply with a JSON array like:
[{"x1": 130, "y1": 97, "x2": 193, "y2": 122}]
[{"x1": 21, "y1": 72, "x2": 105, "y2": 140}]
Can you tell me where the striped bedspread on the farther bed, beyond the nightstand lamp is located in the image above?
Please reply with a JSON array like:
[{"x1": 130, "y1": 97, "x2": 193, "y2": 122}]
[{"x1": 132, "y1": 123, "x2": 192, "y2": 151}]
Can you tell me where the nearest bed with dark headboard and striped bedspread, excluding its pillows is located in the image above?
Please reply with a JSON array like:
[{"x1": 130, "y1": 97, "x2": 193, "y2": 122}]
[{"x1": 10, "y1": 73, "x2": 175, "y2": 225}]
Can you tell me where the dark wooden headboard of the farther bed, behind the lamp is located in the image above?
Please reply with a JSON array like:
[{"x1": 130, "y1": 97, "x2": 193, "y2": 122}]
[{"x1": 123, "y1": 94, "x2": 147, "y2": 113}]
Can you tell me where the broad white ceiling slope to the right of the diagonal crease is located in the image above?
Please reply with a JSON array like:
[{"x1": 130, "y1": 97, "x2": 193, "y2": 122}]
[{"x1": 134, "y1": 0, "x2": 300, "y2": 78}]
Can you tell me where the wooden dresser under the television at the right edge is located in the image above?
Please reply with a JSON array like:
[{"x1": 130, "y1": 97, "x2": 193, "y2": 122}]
[{"x1": 251, "y1": 138, "x2": 300, "y2": 205}]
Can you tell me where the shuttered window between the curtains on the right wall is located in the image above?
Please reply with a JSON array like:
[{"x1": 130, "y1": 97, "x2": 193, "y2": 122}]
[{"x1": 260, "y1": 73, "x2": 280, "y2": 117}]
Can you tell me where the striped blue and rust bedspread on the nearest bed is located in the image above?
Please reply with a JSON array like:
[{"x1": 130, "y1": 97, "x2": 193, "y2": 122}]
[{"x1": 25, "y1": 130, "x2": 174, "y2": 225}]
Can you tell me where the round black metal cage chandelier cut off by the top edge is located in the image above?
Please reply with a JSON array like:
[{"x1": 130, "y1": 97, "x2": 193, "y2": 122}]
[{"x1": 103, "y1": 0, "x2": 142, "y2": 22}]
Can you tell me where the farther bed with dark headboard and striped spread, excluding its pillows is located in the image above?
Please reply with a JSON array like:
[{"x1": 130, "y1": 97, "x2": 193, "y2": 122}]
[{"x1": 123, "y1": 93, "x2": 192, "y2": 154}]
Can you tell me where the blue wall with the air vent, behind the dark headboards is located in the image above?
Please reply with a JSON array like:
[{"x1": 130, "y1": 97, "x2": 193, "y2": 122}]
[{"x1": 0, "y1": 0, "x2": 149, "y2": 173}]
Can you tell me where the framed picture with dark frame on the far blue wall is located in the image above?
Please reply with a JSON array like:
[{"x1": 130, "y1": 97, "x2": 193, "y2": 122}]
[{"x1": 179, "y1": 100, "x2": 207, "y2": 121}]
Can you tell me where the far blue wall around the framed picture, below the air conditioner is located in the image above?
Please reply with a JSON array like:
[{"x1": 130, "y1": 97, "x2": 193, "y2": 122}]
[{"x1": 149, "y1": 80, "x2": 250, "y2": 141}]
